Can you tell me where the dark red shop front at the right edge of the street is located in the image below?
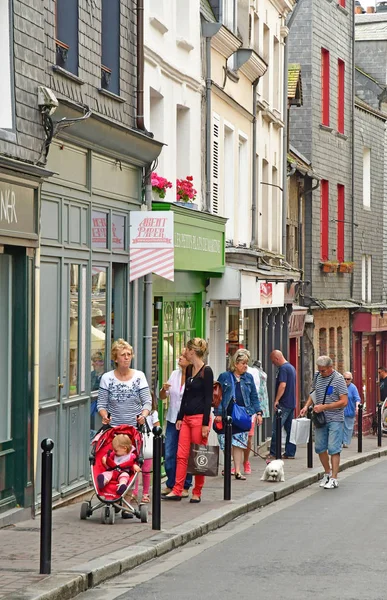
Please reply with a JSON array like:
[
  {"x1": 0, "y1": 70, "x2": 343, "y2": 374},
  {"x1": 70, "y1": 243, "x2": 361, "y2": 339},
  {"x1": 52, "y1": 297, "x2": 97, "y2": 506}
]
[{"x1": 352, "y1": 311, "x2": 387, "y2": 431}]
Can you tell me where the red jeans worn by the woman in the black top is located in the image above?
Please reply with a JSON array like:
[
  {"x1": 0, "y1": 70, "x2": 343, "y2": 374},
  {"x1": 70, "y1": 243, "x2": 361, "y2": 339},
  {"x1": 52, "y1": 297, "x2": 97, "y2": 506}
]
[{"x1": 173, "y1": 415, "x2": 210, "y2": 498}]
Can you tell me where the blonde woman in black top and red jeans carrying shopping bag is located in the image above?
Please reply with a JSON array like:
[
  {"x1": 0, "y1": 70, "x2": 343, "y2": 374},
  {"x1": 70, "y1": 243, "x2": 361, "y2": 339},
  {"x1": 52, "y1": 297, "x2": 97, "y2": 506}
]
[{"x1": 163, "y1": 338, "x2": 214, "y2": 504}]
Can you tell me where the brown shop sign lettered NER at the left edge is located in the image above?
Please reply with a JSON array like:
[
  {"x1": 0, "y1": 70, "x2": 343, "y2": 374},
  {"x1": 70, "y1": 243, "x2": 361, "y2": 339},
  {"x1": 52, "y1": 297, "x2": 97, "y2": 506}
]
[{"x1": 0, "y1": 181, "x2": 37, "y2": 237}]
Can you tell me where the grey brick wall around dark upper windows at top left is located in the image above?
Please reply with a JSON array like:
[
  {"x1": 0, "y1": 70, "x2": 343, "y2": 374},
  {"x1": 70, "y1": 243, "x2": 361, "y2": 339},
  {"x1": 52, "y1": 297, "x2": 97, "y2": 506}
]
[{"x1": 0, "y1": 0, "x2": 137, "y2": 162}]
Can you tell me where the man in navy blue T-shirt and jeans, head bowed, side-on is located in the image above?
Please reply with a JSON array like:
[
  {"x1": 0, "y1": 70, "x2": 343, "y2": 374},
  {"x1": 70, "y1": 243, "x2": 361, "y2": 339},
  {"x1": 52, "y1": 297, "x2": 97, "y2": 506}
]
[{"x1": 268, "y1": 350, "x2": 297, "y2": 460}]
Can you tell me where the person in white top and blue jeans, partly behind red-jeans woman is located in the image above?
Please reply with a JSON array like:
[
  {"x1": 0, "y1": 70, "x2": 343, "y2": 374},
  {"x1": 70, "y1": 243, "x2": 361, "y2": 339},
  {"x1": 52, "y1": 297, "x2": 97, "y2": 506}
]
[{"x1": 160, "y1": 348, "x2": 192, "y2": 498}]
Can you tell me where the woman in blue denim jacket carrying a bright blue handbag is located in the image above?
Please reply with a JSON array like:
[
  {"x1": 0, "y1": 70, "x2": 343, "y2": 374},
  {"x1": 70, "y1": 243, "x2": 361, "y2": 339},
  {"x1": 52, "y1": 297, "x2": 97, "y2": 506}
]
[{"x1": 214, "y1": 349, "x2": 262, "y2": 480}]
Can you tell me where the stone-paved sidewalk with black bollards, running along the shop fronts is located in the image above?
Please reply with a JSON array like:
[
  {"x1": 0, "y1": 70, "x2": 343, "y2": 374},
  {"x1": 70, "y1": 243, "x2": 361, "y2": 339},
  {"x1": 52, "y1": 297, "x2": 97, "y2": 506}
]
[{"x1": 0, "y1": 436, "x2": 387, "y2": 600}]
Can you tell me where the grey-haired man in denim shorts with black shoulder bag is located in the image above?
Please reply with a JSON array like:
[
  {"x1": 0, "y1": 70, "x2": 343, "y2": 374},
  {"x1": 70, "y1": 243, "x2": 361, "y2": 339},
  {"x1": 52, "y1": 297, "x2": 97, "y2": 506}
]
[{"x1": 300, "y1": 356, "x2": 348, "y2": 490}]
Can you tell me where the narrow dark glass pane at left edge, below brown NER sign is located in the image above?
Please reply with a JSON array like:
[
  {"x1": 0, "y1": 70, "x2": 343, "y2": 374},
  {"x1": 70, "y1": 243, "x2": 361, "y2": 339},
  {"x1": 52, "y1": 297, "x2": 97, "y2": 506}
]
[{"x1": 0, "y1": 254, "x2": 12, "y2": 442}]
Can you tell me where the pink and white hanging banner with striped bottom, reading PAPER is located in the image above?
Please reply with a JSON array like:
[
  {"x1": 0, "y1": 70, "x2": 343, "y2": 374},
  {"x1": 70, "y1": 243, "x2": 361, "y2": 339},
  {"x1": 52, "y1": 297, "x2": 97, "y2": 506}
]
[{"x1": 129, "y1": 211, "x2": 175, "y2": 281}]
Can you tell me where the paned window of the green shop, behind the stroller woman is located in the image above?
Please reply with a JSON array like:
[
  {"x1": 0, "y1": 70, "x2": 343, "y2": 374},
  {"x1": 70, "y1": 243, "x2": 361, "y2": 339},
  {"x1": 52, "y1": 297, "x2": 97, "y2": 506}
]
[{"x1": 162, "y1": 300, "x2": 197, "y2": 381}]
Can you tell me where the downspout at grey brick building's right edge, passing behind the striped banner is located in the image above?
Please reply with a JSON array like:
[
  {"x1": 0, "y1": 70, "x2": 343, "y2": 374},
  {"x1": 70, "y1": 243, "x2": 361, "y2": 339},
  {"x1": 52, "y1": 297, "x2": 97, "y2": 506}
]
[{"x1": 135, "y1": 0, "x2": 153, "y2": 387}]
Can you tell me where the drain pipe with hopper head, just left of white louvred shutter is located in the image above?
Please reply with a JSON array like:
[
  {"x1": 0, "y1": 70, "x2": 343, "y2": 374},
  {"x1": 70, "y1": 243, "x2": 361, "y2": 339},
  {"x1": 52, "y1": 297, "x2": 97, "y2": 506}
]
[{"x1": 202, "y1": 21, "x2": 222, "y2": 212}]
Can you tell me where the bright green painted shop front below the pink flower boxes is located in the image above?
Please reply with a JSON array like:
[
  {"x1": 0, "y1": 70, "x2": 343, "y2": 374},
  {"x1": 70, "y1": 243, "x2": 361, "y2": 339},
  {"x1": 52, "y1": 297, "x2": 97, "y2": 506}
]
[{"x1": 153, "y1": 202, "x2": 226, "y2": 422}]
